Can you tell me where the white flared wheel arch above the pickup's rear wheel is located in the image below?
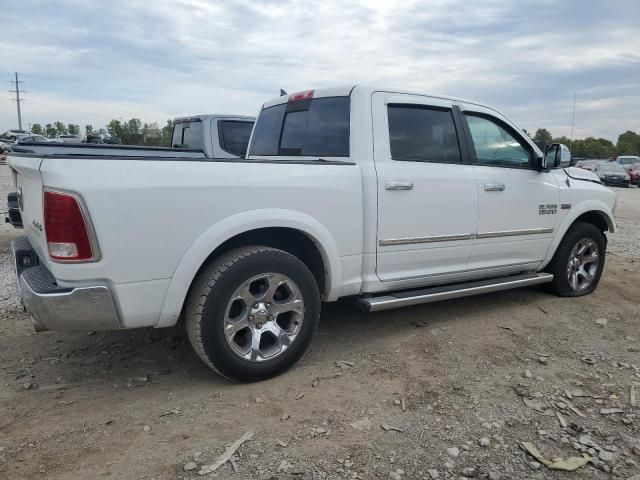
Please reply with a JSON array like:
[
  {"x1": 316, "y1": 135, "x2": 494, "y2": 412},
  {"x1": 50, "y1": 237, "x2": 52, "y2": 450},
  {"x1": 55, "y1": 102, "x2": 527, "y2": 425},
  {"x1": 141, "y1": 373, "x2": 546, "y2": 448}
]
[{"x1": 156, "y1": 209, "x2": 342, "y2": 328}]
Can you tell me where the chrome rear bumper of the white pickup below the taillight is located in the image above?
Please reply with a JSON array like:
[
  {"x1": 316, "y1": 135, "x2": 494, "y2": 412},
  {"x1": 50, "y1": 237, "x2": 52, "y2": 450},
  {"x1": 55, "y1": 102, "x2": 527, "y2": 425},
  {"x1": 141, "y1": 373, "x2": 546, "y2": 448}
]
[{"x1": 11, "y1": 237, "x2": 120, "y2": 332}]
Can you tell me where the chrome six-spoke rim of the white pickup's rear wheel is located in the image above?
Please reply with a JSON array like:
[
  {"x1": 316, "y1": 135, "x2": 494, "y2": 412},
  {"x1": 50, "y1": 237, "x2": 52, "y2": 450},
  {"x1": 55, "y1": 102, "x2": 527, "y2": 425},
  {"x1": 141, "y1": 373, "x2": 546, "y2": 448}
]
[{"x1": 224, "y1": 273, "x2": 304, "y2": 362}]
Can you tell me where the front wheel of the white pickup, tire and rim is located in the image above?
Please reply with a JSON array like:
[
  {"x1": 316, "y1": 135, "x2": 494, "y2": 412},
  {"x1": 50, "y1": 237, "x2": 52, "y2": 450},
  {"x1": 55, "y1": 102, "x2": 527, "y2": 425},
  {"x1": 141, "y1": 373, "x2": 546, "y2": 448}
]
[{"x1": 547, "y1": 222, "x2": 606, "y2": 297}]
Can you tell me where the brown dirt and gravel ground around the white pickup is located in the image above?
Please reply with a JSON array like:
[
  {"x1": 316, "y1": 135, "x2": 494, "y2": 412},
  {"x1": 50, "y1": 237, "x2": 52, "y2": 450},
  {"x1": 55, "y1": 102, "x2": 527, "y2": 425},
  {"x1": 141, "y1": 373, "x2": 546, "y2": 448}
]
[{"x1": 0, "y1": 171, "x2": 640, "y2": 479}]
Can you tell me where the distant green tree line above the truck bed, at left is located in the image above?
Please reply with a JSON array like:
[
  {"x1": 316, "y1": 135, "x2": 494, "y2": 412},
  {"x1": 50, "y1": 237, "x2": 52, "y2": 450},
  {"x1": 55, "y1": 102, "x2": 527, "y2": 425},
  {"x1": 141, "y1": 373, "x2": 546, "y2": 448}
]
[{"x1": 31, "y1": 118, "x2": 173, "y2": 147}]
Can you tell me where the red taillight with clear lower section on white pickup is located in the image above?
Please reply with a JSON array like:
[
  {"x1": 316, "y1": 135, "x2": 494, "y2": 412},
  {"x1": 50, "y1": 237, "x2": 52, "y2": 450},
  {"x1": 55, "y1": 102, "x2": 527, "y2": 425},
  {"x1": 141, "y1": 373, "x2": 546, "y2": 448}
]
[{"x1": 44, "y1": 191, "x2": 93, "y2": 261}]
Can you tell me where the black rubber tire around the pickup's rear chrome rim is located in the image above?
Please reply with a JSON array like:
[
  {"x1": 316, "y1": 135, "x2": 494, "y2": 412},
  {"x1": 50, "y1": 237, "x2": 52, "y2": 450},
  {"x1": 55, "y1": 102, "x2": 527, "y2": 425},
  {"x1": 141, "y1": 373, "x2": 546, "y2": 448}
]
[{"x1": 185, "y1": 246, "x2": 320, "y2": 382}]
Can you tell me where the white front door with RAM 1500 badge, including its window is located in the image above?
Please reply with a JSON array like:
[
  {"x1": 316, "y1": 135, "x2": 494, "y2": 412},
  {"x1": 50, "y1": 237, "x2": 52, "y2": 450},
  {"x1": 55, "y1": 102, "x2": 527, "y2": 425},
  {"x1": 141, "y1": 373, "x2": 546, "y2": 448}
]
[{"x1": 463, "y1": 106, "x2": 560, "y2": 271}]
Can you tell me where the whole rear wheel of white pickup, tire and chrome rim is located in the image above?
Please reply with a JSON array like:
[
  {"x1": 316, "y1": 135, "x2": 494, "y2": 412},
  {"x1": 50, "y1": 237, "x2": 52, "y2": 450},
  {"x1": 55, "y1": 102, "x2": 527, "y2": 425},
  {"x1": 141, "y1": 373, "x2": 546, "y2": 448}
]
[{"x1": 185, "y1": 246, "x2": 320, "y2": 381}]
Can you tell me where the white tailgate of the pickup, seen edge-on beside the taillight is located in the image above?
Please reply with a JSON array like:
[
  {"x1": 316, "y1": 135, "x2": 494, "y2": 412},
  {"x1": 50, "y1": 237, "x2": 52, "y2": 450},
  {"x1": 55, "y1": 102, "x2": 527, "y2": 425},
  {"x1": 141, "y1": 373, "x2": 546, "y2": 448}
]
[{"x1": 7, "y1": 155, "x2": 48, "y2": 263}]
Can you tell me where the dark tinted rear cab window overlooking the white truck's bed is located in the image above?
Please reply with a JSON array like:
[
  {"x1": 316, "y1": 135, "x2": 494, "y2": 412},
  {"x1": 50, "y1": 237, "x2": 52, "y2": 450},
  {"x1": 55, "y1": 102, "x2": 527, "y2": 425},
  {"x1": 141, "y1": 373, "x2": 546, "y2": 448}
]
[{"x1": 249, "y1": 96, "x2": 351, "y2": 158}]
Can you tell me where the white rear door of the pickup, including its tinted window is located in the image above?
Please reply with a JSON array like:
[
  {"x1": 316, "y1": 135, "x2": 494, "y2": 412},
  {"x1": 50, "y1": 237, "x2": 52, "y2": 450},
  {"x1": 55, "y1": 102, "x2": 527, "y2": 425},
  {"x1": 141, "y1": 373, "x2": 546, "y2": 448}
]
[{"x1": 372, "y1": 92, "x2": 478, "y2": 281}]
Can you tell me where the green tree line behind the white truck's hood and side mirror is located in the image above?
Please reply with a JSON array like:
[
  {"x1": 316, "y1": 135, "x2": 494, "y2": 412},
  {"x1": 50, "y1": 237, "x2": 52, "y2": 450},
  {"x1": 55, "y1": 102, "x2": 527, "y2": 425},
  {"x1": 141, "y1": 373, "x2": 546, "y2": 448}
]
[{"x1": 525, "y1": 128, "x2": 640, "y2": 158}]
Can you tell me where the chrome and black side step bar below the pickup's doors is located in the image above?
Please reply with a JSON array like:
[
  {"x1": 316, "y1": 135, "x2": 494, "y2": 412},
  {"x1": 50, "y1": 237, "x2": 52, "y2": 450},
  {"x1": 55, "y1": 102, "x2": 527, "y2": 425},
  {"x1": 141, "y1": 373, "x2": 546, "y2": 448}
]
[{"x1": 356, "y1": 273, "x2": 553, "y2": 312}]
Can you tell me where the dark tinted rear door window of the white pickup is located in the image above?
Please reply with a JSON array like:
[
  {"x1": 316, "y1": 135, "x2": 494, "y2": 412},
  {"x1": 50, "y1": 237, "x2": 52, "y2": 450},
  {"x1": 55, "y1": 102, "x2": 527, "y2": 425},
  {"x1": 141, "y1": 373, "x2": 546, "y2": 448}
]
[{"x1": 388, "y1": 105, "x2": 462, "y2": 163}]
